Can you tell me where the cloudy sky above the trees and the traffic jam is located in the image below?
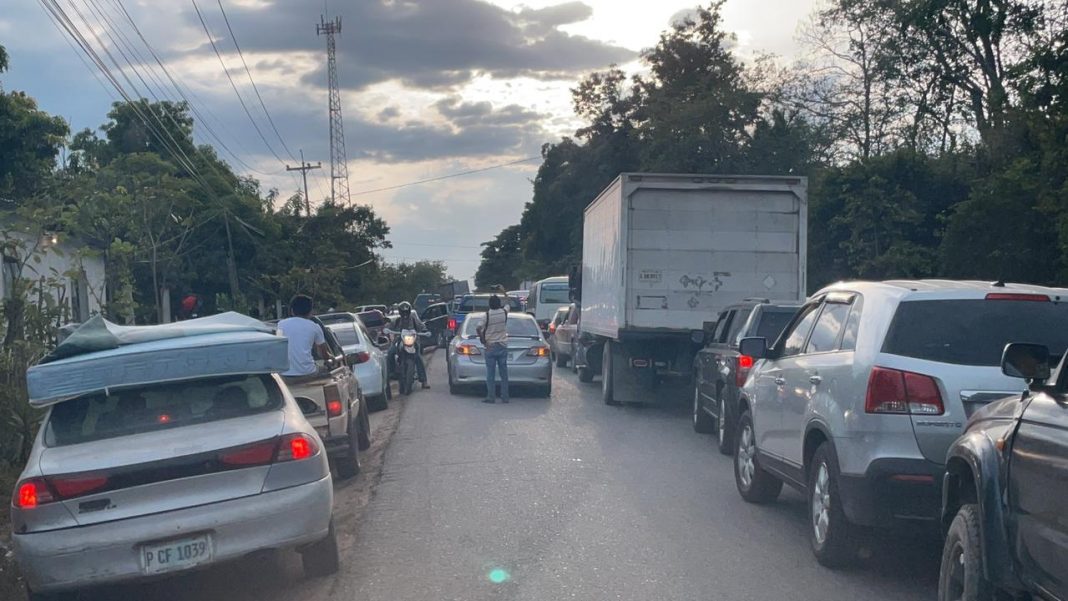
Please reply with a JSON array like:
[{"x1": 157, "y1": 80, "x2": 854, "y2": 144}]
[{"x1": 0, "y1": 0, "x2": 817, "y2": 279}]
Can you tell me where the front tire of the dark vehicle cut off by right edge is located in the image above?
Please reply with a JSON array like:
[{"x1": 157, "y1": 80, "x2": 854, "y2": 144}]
[{"x1": 938, "y1": 504, "x2": 994, "y2": 601}]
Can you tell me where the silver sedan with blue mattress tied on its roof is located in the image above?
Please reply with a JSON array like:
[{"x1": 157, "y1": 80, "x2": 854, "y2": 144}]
[{"x1": 11, "y1": 313, "x2": 339, "y2": 601}]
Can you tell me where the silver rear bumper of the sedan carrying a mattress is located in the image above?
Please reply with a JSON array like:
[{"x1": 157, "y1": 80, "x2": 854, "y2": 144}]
[{"x1": 12, "y1": 476, "x2": 333, "y2": 592}]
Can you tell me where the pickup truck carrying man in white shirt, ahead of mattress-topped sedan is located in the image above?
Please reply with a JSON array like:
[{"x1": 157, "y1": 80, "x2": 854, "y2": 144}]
[{"x1": 283, "y1": 317, "x2": 371, "y2": 479}]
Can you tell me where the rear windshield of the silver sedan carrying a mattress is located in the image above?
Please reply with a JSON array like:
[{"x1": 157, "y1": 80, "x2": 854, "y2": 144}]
[{"x1": 45, "y1": 375, "x2": 282, "y2": 446}]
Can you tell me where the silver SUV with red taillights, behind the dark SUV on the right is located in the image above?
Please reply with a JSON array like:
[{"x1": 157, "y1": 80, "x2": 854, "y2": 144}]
[{"x1": 735, "y1": 281, "x2": 1068, "y2": 566}]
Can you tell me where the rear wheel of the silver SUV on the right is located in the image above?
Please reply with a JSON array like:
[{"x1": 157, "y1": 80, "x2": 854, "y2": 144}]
[{"x1": 807, "y1": 442, "x2": 858, "y2": 568}]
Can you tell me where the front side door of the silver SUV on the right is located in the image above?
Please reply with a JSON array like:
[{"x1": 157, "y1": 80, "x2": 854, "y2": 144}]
[{"x1": 752, "y1": 299, "x2": 822, "y2": 459}]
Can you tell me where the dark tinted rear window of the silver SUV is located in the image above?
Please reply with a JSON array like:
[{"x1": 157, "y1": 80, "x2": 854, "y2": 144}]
[{"x1": 882, "y1": 300, "x2": 1068, "y2": 365}]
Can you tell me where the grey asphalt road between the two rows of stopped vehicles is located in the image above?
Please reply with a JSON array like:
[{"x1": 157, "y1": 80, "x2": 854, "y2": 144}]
[{"x1": 48, "y1": 354, "x2": 940, "y2": 601}]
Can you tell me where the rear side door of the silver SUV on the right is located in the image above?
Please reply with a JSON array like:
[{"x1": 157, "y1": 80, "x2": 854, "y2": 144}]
[{"x1": 782, "y1": 292, "x2": 855, "y2": 466}]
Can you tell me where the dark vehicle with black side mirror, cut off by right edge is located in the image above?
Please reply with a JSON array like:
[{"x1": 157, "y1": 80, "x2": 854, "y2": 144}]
[{"x1": 939, "y1": 344, "x2": 1068, "y2": 601}]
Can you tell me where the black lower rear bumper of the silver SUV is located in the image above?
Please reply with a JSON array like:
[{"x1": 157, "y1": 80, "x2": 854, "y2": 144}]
[{"x1": 838, "y1": 459, "x2": 945, "y2": 527}]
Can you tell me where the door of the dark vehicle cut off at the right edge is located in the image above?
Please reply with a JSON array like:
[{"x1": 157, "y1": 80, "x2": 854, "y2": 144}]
[{"x1": 1008, "y1": 393, "x2": 1068, "y2": 599}]
